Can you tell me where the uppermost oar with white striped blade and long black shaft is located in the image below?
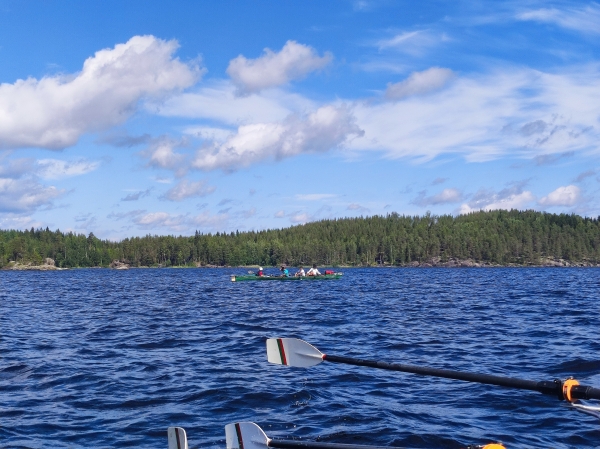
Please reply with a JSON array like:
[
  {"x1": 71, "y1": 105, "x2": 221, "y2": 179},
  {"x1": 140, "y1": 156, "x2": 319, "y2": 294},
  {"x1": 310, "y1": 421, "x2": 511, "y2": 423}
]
[{"x1": 267, "y1": 338, "x2": 600, "y2": 402}]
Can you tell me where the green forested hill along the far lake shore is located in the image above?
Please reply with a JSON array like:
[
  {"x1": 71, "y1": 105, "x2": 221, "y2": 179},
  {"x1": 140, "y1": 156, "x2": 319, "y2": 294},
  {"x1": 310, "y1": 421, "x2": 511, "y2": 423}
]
[{"x1": 0, "y1": 210, "x2": 600, "y2": 268}]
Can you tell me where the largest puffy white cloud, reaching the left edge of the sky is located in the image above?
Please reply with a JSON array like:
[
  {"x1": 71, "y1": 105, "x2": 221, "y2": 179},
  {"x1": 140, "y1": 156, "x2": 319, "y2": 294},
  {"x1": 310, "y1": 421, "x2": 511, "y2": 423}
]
[{"x1": 0, "y1": 36, "x2": 201, "y2": 149}]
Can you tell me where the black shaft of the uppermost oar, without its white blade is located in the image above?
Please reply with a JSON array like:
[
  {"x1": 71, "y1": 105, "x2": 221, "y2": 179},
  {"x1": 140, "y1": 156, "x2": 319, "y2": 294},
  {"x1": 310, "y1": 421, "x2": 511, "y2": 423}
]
[{"x1": 323, "y1": 354, "x2": 600, "y2": 399}]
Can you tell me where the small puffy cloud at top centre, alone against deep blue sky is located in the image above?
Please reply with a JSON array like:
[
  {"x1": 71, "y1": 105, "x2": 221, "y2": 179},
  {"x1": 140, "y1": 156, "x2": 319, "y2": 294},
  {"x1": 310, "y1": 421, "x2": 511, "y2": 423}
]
[{"x1": 227, "y1": 41, "x2": 333, "y2": 93}]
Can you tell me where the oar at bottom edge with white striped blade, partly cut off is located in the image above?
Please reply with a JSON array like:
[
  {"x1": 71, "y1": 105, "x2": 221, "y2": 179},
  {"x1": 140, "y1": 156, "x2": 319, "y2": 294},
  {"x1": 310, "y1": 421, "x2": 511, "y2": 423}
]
[{"x1": 223, "y1": 422, "x2": 505, "y2": 449}]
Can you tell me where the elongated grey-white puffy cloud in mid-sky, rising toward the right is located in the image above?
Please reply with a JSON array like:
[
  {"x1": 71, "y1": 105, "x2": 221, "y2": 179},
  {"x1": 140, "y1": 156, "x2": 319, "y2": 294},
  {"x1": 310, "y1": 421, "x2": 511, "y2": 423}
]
[{"x1": 192, "y1": 105, "x2": 362, "y2": 170}]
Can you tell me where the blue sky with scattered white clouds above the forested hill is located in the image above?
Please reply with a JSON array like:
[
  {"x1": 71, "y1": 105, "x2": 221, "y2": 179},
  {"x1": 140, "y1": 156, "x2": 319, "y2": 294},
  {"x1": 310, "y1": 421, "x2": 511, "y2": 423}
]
[{"x1": 0, "y1": 0, "x2": 600, "y2": 239}]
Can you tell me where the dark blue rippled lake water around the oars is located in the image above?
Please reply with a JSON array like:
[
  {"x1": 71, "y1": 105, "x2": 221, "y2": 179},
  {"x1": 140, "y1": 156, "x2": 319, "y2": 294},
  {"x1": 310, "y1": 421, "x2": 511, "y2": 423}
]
[{"x1": 0, "y1": 268, "x2": 600, "y2": 449}]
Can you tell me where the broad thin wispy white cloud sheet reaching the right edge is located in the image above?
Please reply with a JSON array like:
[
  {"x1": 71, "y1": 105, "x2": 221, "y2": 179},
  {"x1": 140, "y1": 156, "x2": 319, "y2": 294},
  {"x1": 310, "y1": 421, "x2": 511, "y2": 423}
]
[{"x1": 347, "y1": 64, "x2": 600, "y2": 162}]
